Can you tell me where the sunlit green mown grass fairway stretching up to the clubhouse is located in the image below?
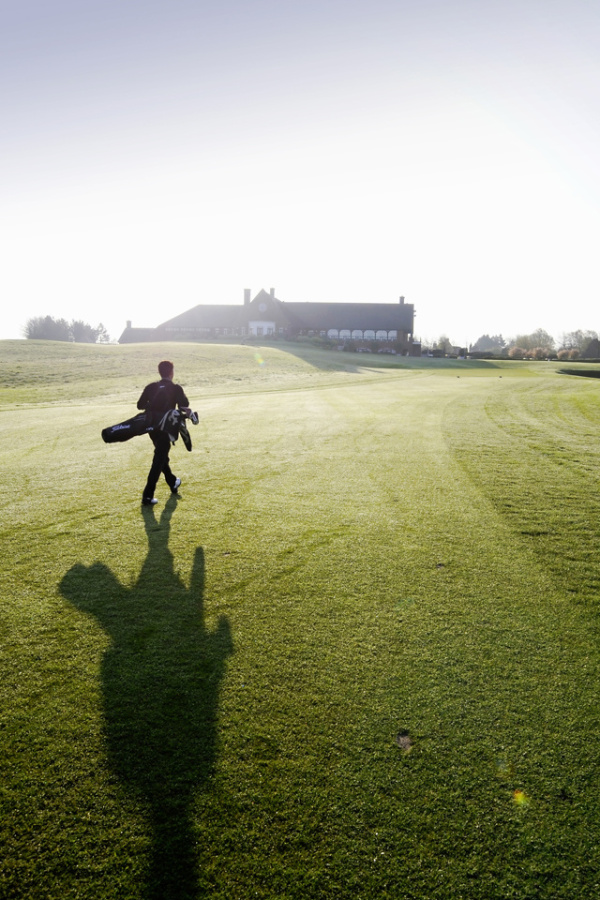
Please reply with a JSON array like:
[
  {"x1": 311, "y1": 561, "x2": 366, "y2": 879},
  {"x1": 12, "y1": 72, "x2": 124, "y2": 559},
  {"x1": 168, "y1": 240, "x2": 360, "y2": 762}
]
[{"x1": 0, "y1": 342, "x2": 600, "y2": 900}]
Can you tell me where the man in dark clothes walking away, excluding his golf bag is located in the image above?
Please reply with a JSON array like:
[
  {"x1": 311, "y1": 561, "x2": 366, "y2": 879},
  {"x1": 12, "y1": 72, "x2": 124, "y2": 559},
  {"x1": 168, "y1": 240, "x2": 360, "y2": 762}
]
[{"x1": 137, "y1": 359, "x2": 191, "y2": 506}]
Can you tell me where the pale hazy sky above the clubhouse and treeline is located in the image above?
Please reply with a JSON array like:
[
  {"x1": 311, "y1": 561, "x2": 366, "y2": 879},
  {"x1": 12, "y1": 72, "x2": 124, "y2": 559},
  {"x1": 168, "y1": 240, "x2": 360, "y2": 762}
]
[{"x1": 0, "y1": 0, "x2": 600, "y2": 343}]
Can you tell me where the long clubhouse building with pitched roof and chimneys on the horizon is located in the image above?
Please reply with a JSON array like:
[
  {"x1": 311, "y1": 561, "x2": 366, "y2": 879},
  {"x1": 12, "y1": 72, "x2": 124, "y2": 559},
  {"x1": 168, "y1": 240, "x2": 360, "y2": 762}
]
[{"x1": 119, "y1": 288, "x2": 420, "y2": 355}]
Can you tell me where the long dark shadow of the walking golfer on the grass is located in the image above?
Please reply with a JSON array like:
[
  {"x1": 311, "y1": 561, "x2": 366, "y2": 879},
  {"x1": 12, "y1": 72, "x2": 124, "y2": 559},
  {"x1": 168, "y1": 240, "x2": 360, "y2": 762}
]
[{"x1": 61, "y1": 497, "x2": 233, "y2": 900}]
